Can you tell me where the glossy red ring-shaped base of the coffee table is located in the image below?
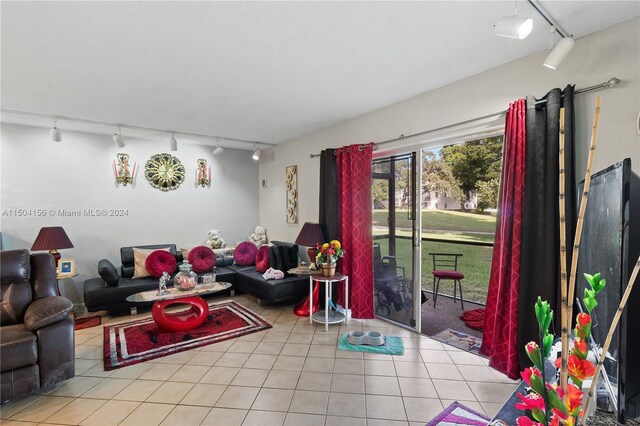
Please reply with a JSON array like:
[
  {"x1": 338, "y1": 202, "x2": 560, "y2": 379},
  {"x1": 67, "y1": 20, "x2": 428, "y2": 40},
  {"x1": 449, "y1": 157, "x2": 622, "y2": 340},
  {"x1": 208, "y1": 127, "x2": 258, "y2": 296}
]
[{"x1": 151, "y1": 296, "x2": 209, "y2": 331}]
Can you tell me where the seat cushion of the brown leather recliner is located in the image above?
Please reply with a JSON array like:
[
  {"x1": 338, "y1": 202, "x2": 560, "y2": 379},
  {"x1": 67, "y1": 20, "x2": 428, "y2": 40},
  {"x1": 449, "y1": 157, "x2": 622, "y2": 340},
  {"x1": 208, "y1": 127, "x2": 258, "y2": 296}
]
[{"x1": 0, "y1": 324, "x2": 38, "y2": 371}]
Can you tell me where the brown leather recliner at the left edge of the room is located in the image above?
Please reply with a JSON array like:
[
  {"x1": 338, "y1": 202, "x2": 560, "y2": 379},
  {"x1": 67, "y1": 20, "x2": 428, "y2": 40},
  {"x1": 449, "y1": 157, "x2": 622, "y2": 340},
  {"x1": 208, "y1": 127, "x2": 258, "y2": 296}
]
[{"x1": 0, "y1": 250, "x2": 75, "y2": 403}]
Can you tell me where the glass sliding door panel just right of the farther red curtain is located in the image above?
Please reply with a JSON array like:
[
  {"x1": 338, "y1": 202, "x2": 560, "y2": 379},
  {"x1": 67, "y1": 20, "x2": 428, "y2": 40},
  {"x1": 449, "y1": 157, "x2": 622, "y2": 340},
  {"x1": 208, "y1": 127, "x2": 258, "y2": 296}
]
[{"x1": 372, "y1": 153, "x2": 420, "y2": 328}]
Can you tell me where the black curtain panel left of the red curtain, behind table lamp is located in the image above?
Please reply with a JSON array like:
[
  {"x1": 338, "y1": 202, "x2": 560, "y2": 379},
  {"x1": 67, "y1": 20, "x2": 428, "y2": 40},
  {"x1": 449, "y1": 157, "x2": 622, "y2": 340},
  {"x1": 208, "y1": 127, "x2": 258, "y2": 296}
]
[{"x1": 319, "y1": 149, "x2": 340, "y2": 241}]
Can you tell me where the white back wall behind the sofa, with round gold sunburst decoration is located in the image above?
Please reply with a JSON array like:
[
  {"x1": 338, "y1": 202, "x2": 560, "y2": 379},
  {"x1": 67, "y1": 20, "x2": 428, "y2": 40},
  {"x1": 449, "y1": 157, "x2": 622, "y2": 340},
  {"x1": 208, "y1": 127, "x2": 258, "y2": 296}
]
[{"x1": 0, "y1": 124, "x2": 258, "y2": 302}]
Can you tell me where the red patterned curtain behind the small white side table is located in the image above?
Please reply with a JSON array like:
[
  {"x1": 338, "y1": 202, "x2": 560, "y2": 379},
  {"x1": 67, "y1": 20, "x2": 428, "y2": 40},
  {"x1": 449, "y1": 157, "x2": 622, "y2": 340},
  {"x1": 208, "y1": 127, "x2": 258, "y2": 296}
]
[{"x1": 336, "y1": 143, "x2": 374, "y2": 318}]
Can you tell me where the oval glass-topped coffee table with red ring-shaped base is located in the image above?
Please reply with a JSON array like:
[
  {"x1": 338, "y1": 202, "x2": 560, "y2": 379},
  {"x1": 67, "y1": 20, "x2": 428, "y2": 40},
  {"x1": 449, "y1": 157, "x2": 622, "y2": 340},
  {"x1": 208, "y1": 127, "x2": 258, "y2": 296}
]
[{"x1": 127, "y1": 282, "x2": 231, "y2": 332}]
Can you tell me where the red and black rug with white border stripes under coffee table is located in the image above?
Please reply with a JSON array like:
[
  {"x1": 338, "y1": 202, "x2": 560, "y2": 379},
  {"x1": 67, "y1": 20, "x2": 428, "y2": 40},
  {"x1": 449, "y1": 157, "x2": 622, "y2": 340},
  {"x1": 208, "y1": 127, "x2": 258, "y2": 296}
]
[{"x1": 104, "y1": 300, "x2": 271, "y2": 371}]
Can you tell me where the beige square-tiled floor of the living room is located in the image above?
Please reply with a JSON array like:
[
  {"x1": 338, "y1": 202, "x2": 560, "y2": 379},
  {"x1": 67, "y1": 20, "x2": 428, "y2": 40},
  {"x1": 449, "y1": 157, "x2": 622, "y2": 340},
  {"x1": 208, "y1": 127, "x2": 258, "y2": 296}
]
[{"x1": 0, "y1": 295, "x2": 517, "y2": 426}]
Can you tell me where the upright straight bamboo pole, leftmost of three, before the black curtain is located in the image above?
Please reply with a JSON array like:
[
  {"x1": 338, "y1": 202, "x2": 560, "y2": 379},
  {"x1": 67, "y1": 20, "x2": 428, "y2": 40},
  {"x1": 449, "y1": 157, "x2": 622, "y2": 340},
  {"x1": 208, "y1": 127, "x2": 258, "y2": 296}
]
[{"x1": 558, "y1": 108, "x2": 569, "y2": 395}]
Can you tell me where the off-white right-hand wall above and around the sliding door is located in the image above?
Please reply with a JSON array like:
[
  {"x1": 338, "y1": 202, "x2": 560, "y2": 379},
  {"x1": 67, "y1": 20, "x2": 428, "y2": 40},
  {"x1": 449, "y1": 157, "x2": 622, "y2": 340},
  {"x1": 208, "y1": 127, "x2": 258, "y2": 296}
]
[{"x1": 260, "y1": 18, "x2": 640, "y2": 240}]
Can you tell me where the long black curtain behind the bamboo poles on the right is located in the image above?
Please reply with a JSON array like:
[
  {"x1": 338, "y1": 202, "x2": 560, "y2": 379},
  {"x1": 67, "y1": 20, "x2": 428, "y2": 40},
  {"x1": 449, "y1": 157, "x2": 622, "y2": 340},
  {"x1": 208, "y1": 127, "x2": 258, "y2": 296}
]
[{"x1": 518, "y1": 86, "x2": 577, "y2": 369}]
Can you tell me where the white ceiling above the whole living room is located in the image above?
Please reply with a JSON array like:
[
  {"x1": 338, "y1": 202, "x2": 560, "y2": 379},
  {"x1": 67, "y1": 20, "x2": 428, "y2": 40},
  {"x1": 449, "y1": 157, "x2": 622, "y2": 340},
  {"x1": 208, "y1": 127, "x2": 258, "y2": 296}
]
[{"x1": 0, "y1": 1, "x2": 640, "y2": 143}]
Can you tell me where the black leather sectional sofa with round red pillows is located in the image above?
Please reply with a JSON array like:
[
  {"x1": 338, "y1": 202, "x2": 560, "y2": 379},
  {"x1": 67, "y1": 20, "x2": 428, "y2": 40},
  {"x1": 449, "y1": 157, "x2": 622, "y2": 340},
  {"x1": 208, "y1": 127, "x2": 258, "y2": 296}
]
[{"x1": 84, "y1": 241, "x2": 309, "y2": 314}]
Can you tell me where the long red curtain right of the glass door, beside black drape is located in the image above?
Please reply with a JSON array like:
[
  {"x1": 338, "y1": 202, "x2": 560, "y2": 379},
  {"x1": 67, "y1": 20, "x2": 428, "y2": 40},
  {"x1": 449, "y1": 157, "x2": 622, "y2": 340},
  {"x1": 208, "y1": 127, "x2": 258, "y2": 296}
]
[{"x1": 480, "y1": 99, "x2": 526, "y2": 379}]
